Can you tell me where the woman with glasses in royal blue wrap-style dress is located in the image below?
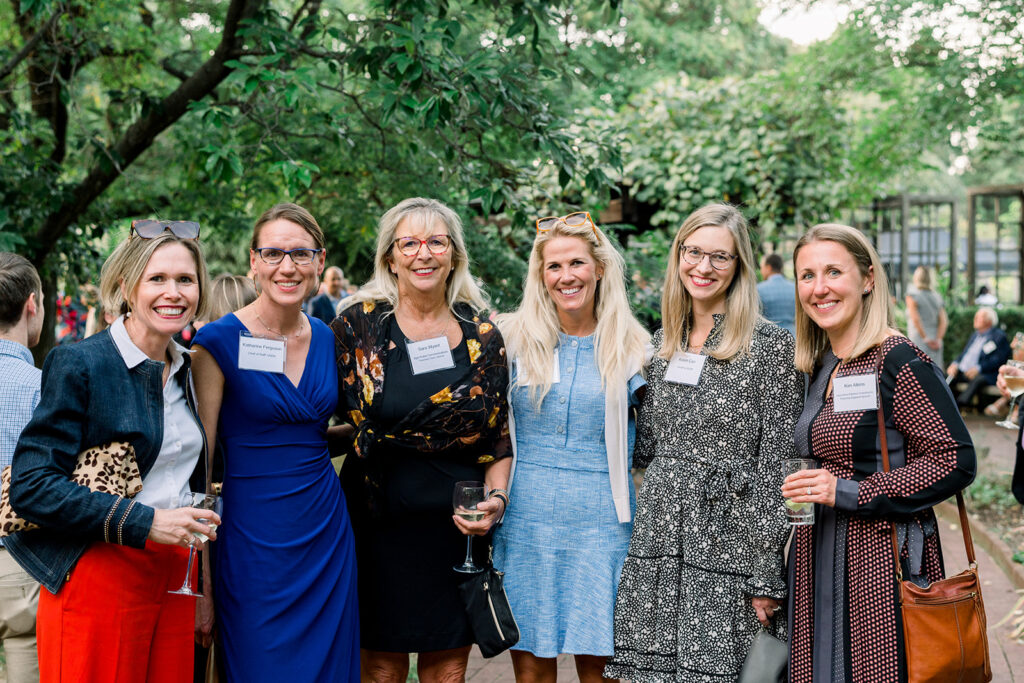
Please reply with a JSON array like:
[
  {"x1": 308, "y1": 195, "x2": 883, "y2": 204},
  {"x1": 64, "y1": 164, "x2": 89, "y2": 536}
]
[{"x1": 193, "y1": 204, "x2": 359, "y2": 683}]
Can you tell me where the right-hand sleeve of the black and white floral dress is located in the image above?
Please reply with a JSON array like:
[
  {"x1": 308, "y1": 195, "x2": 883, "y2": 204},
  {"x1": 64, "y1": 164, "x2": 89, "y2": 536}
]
[{"x1": 746, "y1": 327, "x2": 804, "y2": 599}]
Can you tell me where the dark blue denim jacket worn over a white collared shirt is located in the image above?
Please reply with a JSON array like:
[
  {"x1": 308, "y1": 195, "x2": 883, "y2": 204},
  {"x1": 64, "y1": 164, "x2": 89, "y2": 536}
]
[{"x1": 4, "y1": 330, "x2": 206, "y2": 594}]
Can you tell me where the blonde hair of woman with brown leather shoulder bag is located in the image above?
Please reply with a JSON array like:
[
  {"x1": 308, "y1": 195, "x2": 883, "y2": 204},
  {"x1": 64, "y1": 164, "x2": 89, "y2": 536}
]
[{"x1": 793, "y1": 223, "x2": 894, "y2": 373}]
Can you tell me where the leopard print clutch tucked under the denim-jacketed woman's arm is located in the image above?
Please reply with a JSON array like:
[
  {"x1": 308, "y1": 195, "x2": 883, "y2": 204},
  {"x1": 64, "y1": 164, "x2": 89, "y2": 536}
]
[{"x1": 0, "y1": 441, "x2": 142, "y2": 537}]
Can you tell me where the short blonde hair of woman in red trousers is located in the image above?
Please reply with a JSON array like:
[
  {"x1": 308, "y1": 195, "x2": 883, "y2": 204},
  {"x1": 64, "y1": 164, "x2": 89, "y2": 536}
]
[{"x1": 99, "y1": 230, "x2": 210, "y2": 317}]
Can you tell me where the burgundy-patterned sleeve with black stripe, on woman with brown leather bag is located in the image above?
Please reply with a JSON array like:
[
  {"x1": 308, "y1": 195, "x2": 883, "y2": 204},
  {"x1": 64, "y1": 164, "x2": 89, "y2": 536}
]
[{"x1": 857, "y1": 343, "x2": 977, "y2": 517}]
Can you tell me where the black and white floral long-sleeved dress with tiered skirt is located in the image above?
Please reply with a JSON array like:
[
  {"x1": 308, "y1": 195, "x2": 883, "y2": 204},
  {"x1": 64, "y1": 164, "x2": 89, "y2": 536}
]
[{"x1": 605, "y1": 315, "x2": 804, "y2": 683}]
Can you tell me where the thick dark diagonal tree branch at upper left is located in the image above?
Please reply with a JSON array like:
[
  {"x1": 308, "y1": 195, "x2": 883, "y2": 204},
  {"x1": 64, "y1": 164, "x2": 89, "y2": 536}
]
[{"x1": 33, "y1": 0, "x2": 266, "y2": 265}]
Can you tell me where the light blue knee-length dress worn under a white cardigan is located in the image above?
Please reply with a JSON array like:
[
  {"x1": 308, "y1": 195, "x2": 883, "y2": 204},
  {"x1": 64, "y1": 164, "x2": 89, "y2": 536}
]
[{"x1": 494, "y1": 333, "x2": 645, "y2": 657}]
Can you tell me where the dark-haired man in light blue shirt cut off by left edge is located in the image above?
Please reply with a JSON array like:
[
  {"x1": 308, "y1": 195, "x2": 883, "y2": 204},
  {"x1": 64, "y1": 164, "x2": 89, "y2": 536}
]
[{"x1": 0, "y1": 252, "x2": 43, "y2": 683}]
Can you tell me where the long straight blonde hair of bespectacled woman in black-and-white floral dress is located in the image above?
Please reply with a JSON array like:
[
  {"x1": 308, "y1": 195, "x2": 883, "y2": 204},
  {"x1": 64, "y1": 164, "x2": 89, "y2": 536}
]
[{"x1": 657, "y1": 204, "x2": 761, "y2": 360}]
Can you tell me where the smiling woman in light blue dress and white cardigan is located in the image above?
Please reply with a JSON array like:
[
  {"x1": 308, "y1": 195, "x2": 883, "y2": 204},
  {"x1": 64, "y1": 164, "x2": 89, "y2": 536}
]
[{"x1": 495, "y1": 212, "x2": 649, "y2": 682}]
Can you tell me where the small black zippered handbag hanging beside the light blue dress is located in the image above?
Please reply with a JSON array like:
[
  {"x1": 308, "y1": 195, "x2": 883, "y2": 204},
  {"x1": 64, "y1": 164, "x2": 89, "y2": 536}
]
[{"x1": 459, "y1": 553, "x2": 519, "y2": 657}]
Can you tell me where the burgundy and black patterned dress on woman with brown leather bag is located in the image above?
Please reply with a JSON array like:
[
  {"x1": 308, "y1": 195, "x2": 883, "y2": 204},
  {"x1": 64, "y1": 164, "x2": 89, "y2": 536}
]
[{"x1": 788, "y1": 336, "x2": 975, "y2": 683}]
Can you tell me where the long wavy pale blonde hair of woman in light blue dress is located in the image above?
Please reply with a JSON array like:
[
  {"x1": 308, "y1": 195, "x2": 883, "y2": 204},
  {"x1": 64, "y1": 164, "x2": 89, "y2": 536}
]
[{"x1": 498, "y1": 221, "x2": 650, "y2": 407}]
